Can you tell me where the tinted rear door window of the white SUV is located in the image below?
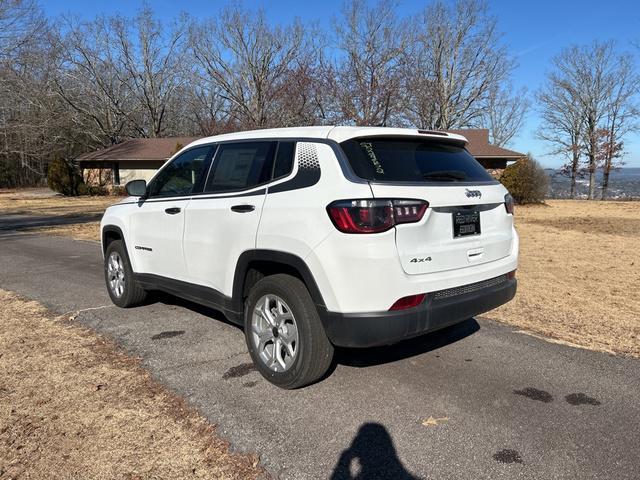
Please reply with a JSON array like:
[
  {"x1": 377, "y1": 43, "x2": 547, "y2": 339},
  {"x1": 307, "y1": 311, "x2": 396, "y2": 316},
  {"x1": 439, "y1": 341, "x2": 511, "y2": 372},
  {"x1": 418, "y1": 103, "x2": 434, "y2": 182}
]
[{"x1": 204, "y1": 142, "x2": 276, "y2": 192}]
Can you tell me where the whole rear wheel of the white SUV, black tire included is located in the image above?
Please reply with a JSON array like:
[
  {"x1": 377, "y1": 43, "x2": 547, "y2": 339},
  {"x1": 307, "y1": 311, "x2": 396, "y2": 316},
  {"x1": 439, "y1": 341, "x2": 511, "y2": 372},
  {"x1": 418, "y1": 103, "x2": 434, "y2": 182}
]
[{"x1": 244, "y1": 274, "x2": 333, "y2": 389}]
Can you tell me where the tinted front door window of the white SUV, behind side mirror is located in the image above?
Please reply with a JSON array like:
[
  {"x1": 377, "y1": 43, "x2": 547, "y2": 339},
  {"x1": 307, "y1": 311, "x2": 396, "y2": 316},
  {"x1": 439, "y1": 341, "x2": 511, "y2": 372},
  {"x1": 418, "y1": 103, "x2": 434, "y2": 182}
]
[{"x1": 149, "y1": 146, "x2": 211, "y2": 197}]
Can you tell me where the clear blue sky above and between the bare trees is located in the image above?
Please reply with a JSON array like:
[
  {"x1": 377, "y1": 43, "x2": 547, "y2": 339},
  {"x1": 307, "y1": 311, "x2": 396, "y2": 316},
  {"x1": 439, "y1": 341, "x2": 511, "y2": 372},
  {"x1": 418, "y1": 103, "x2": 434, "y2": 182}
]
[{"x1": 42, "y1": 0, "x2": 640, "y2": 167}]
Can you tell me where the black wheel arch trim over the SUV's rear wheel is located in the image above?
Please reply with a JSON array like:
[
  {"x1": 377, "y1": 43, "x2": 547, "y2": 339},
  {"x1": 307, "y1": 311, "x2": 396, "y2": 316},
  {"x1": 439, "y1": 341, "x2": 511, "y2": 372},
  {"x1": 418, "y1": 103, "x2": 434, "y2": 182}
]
[{"x1": 232, "y1": 249, "x2": 324, "y2": 311}]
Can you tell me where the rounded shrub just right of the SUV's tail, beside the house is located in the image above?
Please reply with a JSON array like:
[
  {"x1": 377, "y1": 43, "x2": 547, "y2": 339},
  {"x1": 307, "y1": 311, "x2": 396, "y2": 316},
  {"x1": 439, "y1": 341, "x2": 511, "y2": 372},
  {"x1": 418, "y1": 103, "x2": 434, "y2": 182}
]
[{"x1": 500, "y1": 155, "x2": 549, "y2": 204}]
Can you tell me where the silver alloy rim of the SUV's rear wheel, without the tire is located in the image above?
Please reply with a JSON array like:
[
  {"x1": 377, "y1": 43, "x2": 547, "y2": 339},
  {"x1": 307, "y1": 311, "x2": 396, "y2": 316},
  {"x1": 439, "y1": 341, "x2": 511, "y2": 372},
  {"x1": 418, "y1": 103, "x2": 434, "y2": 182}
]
[{"x1": 251, "y1": 295, "x2": 298, "y2": 372}]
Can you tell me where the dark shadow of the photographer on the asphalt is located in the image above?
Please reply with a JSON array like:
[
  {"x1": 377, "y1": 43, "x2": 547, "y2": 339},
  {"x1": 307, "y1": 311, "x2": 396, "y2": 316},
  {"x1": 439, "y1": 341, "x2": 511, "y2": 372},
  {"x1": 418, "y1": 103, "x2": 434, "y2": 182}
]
[{"x1": 331, "y1": 423, "x2": 420, "y2": 480}]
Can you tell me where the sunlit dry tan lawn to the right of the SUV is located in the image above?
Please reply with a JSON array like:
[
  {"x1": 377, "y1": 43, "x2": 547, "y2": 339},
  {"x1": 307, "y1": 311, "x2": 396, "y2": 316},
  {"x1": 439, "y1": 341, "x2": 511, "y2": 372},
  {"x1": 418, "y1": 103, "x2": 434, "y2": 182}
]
[{"x1": 487, "y1": 200, "x2": 640, "y2": 357}]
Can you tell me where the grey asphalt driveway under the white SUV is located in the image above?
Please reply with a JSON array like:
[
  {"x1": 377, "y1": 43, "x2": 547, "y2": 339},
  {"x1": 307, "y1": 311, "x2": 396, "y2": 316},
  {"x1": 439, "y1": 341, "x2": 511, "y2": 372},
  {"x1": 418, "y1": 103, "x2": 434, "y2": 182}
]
[{"x1": 0, "y1": 234, "x2": 640, "y2": 479}]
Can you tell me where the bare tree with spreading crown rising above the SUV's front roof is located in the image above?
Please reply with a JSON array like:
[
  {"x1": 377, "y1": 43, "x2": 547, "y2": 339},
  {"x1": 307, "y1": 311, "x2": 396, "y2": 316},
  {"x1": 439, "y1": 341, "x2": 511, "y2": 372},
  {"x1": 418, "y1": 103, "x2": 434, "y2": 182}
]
[{"x1": 190, "y1": 6, "x2": 320, "y2": 128}]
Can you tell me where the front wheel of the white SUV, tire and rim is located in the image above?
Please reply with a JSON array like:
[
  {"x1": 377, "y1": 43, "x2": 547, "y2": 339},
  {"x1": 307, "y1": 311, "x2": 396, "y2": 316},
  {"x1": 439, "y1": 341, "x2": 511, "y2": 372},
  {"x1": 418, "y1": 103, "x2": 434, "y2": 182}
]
[{"x1": 104, "y1": 240, "x2": 147, "y2": 308}]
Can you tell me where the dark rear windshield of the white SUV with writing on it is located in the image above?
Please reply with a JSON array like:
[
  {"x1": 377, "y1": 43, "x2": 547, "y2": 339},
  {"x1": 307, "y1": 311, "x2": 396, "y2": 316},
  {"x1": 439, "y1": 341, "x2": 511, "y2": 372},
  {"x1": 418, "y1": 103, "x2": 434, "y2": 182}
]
[{"x1": 341, "y1": 137, "x2": 494, "y2": 183}]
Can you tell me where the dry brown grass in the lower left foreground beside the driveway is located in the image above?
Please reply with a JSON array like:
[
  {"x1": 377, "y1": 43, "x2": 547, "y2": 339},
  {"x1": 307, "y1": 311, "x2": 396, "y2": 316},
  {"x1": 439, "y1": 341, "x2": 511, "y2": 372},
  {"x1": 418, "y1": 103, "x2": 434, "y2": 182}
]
[{"x1": 0, "y1": 290, "x2": 264, "y2": 479}]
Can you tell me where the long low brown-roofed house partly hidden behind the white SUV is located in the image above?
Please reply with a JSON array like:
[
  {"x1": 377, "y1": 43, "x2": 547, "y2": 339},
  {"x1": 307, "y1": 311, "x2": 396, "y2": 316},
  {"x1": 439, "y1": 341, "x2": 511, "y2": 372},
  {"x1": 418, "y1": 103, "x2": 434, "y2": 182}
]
[{"x1": 77, "y1": 129, "x2": 524, "y2": 186}]
